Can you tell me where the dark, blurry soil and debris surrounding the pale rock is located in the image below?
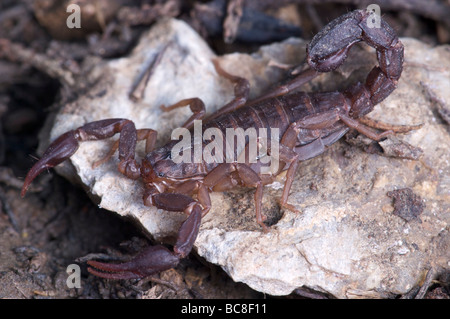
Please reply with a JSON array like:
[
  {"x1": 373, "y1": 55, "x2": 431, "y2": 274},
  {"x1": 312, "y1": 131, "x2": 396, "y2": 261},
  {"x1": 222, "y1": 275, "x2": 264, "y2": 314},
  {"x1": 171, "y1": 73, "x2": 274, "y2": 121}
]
[{"x1": 0, "y1": 0, "x2": 450, "y2": 299}]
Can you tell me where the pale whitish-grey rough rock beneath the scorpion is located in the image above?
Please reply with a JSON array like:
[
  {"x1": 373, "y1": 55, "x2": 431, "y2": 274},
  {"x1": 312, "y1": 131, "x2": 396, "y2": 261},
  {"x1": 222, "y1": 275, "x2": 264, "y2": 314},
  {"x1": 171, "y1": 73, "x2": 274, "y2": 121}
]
[{"x1": 43, "y1": 20, "x2": 450, "y2": 298}]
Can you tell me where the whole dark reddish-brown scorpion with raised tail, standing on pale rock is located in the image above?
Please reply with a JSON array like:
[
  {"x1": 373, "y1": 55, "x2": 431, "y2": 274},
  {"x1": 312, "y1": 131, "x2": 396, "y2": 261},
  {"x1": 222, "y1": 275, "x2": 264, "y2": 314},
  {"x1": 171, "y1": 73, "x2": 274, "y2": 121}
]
[{"x1": 21, "y1": 10, "x2": 414, "y2": 279}]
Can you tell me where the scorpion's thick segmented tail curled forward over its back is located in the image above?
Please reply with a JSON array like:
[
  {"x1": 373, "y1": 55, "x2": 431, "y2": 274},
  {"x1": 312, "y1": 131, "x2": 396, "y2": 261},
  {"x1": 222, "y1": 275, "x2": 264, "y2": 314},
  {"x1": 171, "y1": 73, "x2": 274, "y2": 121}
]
[{"x1": 307, "y1": 10, "x2": 403, "y2": 118}]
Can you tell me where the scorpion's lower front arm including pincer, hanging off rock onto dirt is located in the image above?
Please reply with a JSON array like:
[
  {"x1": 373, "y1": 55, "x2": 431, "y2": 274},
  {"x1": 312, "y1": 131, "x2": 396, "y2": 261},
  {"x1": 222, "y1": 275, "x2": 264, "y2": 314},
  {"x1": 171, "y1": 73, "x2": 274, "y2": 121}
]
[{"x1": 87, "y1": 202, "x2": 202, "y2": 279}]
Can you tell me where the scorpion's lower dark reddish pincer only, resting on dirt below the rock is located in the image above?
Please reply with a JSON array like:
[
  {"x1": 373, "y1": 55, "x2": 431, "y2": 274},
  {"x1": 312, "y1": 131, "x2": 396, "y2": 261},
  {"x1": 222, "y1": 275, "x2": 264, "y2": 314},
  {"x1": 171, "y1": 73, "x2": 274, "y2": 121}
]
[{"x1": 87, "y1": 246, "x2": 180, "y2": 279}]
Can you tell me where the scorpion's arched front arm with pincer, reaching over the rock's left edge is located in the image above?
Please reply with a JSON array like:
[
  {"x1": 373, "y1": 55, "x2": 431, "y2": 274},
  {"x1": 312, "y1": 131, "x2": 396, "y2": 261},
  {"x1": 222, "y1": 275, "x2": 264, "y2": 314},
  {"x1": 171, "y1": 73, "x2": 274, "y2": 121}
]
[{"x1": 21, "y1": 119, "x2": 146, "y2": 197}]
